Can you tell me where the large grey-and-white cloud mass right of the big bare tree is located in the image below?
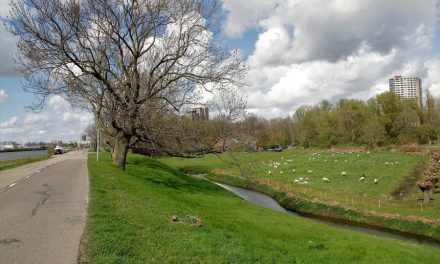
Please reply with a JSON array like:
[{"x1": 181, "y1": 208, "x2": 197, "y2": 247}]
[{"x1": 223, "y1": 0, "x2": 440, "y2": 117}]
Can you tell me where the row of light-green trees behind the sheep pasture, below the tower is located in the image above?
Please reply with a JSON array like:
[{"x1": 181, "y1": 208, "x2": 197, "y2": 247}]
[{"x1": 241, "y1": 92, "x2": 440, "y2": 148}]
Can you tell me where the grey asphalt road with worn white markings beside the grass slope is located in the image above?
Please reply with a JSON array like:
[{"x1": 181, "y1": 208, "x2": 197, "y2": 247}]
[{"x1": 0, "y1": 151, "x2": 88, "y2": 264}]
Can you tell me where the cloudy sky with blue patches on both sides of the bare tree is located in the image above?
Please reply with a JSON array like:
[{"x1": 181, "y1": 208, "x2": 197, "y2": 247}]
[{"x1": 0, "y1": 0, "x2": 440, "y2": 142}]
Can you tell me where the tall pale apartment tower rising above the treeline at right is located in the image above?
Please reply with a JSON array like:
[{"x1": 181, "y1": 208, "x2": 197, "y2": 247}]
[{"x1": 390, "y1": 76, "x2": 422, "y2": 107}]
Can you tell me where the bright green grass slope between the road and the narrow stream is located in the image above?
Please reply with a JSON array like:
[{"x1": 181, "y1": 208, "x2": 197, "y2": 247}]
[{"x1": 81, "y1": 154, "x2": 440, "y2": 263}]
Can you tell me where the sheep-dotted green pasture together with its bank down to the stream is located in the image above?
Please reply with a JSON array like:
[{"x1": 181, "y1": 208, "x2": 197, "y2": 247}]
[{"x1": 163, "y1": 150, "x2": 440, "y2": 239}]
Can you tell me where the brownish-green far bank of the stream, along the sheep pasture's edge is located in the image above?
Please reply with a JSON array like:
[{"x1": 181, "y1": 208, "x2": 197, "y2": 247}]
[{"x1": 206, "y1": 174, "x2": 440, "y2": 246}]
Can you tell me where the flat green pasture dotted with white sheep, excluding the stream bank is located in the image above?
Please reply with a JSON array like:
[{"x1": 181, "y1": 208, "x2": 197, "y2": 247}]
[{"x1": 162, "y1": 150, "x2": 440, "y2": 230}]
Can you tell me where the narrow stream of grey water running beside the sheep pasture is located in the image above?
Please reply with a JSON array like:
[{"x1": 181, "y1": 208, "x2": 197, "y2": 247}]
[{"x1": 193, "y1": 174, "x2": 440, "y2": 248}]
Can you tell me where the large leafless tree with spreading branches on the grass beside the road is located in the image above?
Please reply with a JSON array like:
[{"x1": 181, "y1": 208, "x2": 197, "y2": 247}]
[{"x1": 7, "y1": 0, "x2": 246, "y2": 169}]
